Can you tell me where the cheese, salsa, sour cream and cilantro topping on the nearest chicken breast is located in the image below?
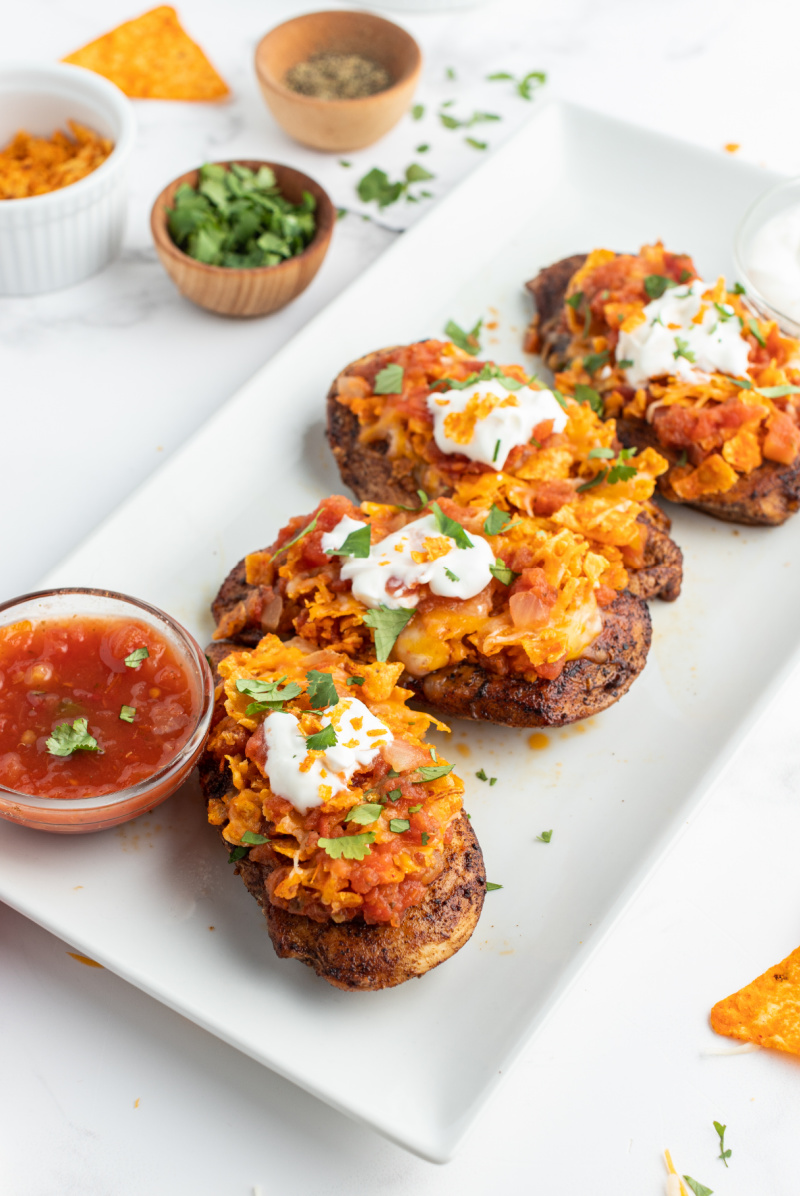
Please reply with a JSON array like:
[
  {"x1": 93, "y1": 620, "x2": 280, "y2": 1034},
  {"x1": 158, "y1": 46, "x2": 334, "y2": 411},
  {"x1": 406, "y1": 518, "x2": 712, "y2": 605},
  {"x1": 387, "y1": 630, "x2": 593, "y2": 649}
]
[{"x1": 207, "y1": 635, "x2": 464, "y2": 926}]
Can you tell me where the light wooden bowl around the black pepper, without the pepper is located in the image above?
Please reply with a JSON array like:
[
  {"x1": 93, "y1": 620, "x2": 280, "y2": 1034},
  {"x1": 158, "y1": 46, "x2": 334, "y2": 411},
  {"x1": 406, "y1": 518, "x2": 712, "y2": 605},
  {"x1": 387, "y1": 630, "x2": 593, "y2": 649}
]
[{"x1": 256, "y1": 12, "x2": 422, "y2": 153}]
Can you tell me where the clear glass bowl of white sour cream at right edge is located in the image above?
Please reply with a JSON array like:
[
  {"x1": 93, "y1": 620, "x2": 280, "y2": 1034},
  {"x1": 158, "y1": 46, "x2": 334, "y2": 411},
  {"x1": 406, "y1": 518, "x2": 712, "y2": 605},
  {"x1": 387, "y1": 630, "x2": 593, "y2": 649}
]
[{"x1": 733, "y1": 178, "x2": 800, "y2": 336}]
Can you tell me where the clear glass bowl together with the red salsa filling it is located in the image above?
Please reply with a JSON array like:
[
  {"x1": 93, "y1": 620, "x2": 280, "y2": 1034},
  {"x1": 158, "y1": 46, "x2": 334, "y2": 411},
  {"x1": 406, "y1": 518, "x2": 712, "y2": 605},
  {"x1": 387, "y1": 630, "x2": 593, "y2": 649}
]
[{"x1": 0, "y1": 588, "x2": 214, "y2": 835}]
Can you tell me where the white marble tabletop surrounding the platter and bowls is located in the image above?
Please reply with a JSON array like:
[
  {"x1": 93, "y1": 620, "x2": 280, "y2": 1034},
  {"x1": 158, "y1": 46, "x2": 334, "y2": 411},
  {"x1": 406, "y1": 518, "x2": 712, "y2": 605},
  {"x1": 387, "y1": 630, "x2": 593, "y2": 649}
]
[{"x1": 0, "y1": 0, "x2": 800, "y2": 1196}]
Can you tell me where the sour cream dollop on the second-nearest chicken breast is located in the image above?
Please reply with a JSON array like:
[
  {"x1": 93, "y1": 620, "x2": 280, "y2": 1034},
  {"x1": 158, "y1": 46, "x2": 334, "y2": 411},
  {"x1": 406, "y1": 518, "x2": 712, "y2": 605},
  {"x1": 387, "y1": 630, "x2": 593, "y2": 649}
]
[{"x1": 322, "y1": 515, "x2": 495, "y2": 610}]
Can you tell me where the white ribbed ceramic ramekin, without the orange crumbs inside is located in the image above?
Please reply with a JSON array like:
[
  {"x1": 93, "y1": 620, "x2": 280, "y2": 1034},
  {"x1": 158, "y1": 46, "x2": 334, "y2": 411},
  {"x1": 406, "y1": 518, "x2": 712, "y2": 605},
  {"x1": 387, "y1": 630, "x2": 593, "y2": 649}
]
[{"x1": 0, "y1": 62, "x2": 136, "y2": 295}]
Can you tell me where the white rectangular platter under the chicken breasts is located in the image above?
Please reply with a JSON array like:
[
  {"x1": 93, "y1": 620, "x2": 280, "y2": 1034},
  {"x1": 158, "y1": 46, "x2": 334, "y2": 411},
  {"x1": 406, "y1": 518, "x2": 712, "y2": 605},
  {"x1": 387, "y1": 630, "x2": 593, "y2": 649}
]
[{"x1": 0, "y1": 104, "x2": 800, "y2": 1161}]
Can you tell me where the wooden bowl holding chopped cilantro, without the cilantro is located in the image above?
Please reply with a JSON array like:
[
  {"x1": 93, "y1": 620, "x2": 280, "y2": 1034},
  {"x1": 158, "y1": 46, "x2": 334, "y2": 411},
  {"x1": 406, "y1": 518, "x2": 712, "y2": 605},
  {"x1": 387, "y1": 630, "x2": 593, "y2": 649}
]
[{"x1": 149, "y1": 159, "x2": 336, "y2": 316}]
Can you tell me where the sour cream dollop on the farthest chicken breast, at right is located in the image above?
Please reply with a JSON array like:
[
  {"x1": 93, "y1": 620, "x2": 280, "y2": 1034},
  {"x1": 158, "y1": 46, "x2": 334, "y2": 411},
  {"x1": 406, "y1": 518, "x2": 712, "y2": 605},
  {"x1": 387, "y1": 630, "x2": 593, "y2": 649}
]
[{"x1": 617, "y1": 279, "x2": 750, "y2": 386}]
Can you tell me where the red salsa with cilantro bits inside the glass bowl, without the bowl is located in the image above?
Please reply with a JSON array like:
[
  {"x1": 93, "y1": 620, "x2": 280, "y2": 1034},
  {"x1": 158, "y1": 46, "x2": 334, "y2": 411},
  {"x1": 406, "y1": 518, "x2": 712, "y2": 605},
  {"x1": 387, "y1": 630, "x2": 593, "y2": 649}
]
[{"x1": 0, "y1": 615, "x2": 199, "y2": 798}]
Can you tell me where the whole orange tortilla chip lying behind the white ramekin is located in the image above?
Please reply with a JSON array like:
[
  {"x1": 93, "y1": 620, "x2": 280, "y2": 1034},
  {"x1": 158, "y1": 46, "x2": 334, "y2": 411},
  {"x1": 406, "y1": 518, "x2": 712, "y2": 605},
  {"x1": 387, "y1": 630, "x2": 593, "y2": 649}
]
[{"x1": 63, "y1": 5, "x2": 228, "y2": 99}]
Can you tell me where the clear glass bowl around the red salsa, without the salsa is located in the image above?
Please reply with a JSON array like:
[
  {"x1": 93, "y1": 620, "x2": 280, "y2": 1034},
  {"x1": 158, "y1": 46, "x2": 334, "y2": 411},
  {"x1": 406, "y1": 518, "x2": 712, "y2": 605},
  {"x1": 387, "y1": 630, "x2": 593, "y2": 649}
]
[{"x1": 0, "y1": 588, "x2": 214, "y2": 835}]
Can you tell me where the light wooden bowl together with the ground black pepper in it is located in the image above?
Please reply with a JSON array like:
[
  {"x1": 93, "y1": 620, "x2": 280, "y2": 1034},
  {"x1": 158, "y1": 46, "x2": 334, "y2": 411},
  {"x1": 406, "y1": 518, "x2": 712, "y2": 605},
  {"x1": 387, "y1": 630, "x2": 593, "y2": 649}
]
[{"x1": 256, "y1": 12, "x2": 422, "y2": 153}]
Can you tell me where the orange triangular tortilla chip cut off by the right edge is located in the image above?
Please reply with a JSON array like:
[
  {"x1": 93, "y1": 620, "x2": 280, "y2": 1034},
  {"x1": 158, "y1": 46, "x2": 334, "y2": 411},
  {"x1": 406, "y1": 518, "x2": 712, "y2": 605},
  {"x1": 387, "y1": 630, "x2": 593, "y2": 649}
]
[{"x1": 710, "y1": 947, "x2": 800, "y2": 1055}]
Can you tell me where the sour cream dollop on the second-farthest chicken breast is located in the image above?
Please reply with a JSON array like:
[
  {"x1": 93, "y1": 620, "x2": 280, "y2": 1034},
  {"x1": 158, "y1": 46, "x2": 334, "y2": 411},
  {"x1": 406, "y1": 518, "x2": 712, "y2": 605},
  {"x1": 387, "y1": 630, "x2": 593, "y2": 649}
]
[{"x1": 427, "y1": 378, "x2": 567, "y2": 469}]
